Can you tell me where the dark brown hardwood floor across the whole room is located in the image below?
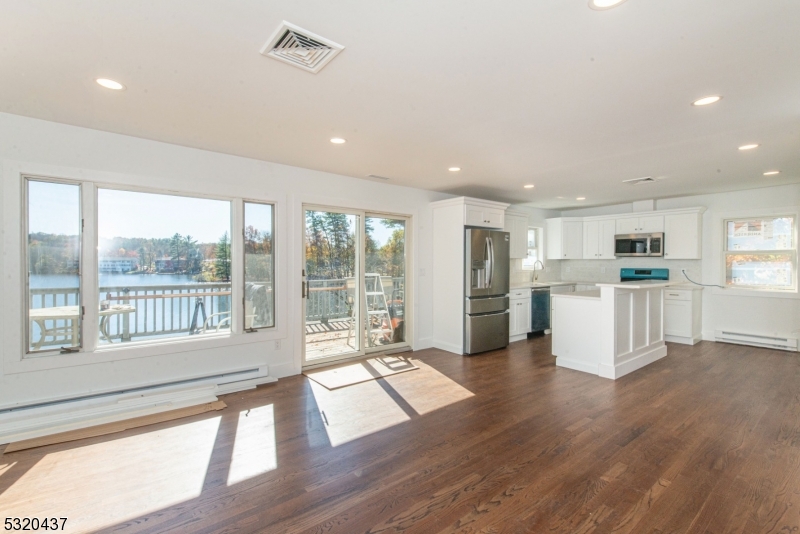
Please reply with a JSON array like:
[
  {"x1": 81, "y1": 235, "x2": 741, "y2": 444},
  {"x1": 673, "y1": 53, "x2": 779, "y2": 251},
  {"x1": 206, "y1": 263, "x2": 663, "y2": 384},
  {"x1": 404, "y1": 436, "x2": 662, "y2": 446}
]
[{"x1": 0, "y1": 337, "x2": 800, "y2": 534}]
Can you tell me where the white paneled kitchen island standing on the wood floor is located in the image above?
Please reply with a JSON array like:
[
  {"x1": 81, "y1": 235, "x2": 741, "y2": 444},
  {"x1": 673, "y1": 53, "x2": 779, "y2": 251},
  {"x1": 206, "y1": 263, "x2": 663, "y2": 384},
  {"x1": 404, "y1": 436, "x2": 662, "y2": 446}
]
[{"x1": 550, "y1": 280, "x2": 670, "y2": 379}]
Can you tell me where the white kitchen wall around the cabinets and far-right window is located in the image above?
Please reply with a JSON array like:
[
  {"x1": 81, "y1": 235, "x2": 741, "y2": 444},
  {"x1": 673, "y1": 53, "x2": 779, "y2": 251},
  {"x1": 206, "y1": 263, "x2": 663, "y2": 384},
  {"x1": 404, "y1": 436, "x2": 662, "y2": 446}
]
[{"x1": 561, "y1": 184, "x2": 800, "y2": 339}]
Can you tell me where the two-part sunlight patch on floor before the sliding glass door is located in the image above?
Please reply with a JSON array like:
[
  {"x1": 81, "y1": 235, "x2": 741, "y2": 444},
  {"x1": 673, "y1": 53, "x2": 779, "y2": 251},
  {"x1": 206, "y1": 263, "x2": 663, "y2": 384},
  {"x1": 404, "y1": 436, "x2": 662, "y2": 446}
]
[{"x1": 308, "y1": 360, "x2": 475, "y2": 447}]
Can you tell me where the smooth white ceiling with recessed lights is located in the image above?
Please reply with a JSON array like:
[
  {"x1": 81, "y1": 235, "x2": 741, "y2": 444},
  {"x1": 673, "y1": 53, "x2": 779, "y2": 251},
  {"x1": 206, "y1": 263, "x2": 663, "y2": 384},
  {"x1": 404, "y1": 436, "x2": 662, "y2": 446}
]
[{"x1": 0, "y1": 0, "x2": 800, "y2": 209}]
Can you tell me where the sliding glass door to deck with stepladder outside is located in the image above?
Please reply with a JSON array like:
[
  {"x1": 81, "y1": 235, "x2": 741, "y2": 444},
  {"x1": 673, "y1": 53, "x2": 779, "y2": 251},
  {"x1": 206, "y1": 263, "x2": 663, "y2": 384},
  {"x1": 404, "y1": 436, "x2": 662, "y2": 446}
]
[{"x1": 303, "y1": 206, "x2": 407, "y2": 365}]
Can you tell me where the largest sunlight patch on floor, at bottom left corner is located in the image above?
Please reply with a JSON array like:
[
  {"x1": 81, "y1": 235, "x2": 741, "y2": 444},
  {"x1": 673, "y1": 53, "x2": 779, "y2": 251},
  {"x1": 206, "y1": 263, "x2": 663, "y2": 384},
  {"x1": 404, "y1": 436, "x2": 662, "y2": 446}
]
[{"x1": 0, "y1": 417, "x2": 220, "y2": 532}]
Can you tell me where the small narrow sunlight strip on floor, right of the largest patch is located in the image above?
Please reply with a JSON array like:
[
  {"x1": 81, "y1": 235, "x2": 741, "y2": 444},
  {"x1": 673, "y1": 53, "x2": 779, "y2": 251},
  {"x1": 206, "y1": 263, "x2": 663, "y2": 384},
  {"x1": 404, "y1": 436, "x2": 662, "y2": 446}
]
[{"x1": 228, "y1": 404, "x2": 278, "y2": 486}]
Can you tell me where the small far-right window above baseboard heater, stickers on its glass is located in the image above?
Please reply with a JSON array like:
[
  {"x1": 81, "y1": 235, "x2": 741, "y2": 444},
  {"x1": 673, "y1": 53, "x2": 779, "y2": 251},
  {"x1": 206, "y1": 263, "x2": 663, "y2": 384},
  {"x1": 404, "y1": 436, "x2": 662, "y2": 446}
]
[{"x1": 725, "y1": 216, "x2": 797, "y2": 290}]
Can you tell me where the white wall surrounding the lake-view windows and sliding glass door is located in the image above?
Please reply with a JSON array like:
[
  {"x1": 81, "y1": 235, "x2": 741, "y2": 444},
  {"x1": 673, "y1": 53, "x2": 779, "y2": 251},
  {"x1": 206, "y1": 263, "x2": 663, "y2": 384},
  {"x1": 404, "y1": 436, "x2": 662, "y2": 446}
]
[{"x1": 0, "y1": 113, "x2": 449, "y2": 407}]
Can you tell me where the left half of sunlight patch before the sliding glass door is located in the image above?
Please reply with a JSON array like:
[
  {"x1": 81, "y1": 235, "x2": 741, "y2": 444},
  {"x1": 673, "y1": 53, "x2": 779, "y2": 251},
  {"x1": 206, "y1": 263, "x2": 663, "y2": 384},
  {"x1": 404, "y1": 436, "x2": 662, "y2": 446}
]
[{"x1": 308, "y1": 380, "x2": 411, "y2": 447}]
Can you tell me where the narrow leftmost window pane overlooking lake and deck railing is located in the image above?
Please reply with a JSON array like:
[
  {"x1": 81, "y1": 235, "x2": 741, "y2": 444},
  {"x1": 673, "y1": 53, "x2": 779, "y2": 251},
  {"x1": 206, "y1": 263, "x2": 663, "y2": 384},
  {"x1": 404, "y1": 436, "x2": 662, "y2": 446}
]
[{"x1": 25, "y1": 179, "x2": 83, "y2": 353}]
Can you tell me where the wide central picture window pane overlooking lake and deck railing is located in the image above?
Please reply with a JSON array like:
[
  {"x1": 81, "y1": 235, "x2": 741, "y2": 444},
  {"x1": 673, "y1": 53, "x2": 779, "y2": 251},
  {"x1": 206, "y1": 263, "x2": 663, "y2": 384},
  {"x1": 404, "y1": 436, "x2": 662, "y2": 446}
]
[{"x1": 97, "y1": 189, "x2": 231, "y2": 345}]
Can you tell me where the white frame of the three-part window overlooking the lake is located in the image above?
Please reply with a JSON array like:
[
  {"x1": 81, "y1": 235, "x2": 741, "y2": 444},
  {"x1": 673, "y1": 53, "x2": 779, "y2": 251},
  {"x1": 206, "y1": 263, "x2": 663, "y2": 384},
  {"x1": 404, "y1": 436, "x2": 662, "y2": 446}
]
[{"x1": 2, "y1": 170, "x2": 286, "y2": 375}]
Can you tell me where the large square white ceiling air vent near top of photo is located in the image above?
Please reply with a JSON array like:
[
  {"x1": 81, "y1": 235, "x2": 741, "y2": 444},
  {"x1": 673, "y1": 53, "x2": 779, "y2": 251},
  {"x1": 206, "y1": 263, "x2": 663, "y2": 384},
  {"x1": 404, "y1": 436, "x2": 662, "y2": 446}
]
[{"x1": 261, "y1": 20, "x2": 344, "y2": 74}]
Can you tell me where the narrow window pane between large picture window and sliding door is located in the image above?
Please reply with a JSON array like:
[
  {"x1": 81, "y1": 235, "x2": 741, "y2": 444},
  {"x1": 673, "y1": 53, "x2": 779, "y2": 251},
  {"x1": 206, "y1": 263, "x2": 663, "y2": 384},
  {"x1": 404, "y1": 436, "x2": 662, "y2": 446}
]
[{"x1": 244, "y1": 202, "x2": 275, "y2": 331}]
